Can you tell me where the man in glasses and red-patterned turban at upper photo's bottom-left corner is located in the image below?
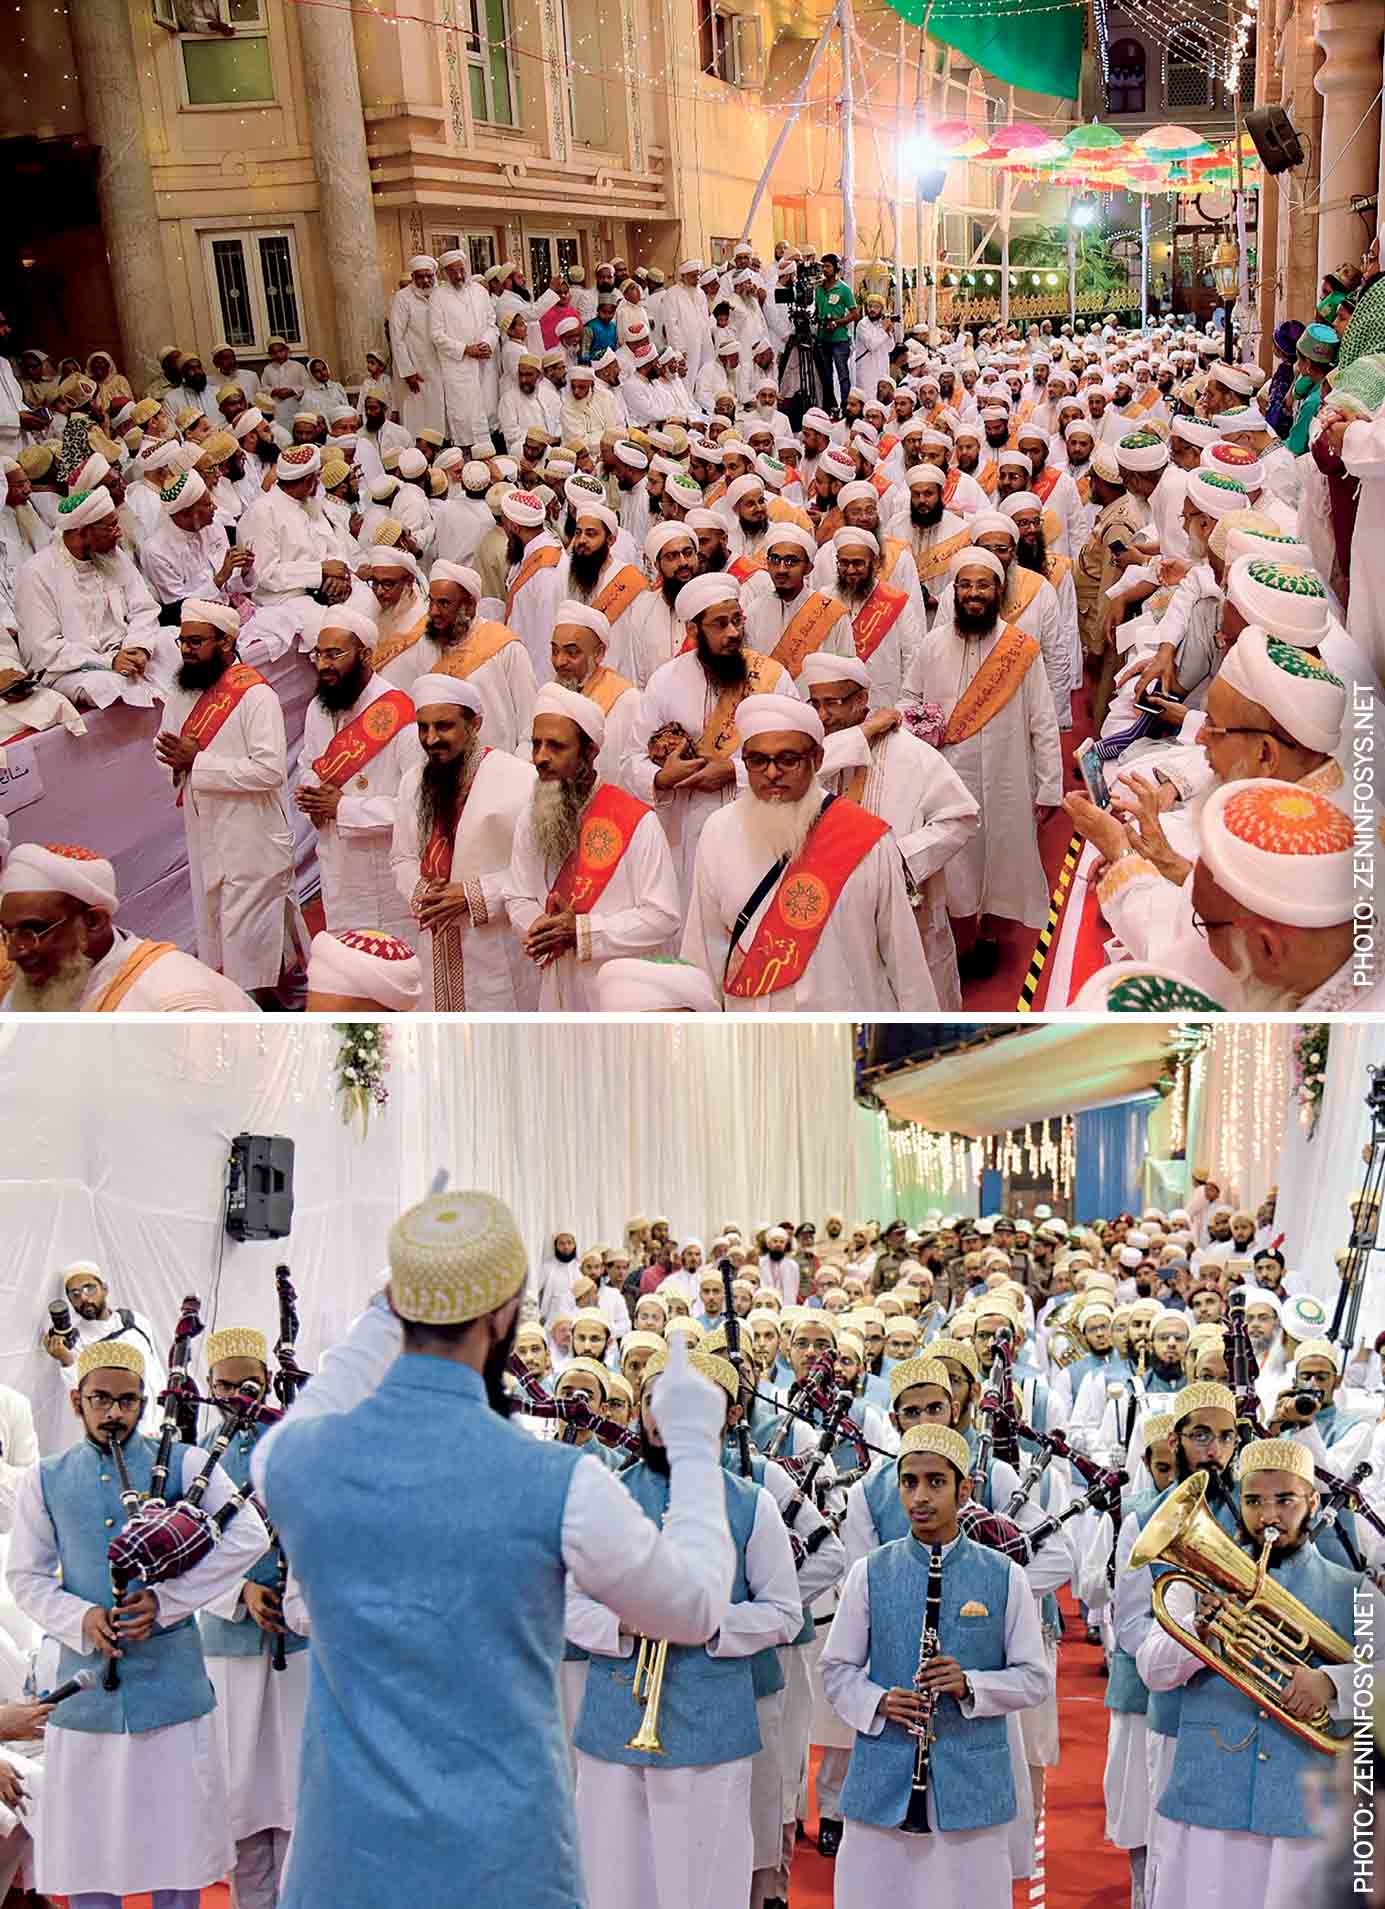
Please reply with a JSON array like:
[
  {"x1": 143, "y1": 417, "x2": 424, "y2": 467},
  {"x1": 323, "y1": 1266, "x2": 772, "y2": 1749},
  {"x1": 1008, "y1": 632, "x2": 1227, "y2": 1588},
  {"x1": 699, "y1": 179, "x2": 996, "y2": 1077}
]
[{"x1": 0, "y1": 842, "x2": 256, "y2": 1014}]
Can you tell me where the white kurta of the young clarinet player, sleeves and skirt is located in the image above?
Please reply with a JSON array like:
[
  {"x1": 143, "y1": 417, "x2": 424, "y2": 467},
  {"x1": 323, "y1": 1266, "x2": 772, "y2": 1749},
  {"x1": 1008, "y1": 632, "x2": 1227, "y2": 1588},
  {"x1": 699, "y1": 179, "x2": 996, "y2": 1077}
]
[{"x1": 820, "y1": 1546, "x2": 1053, "y2": 1909}]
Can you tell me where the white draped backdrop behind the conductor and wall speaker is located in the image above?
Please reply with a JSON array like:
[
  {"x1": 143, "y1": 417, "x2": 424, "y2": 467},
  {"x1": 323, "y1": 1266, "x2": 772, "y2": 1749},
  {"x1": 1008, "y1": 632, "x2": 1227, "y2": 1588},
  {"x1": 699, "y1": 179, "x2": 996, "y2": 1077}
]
[{"x1": 0, "y1": 1019, "x2": 857, "y2": 1451}]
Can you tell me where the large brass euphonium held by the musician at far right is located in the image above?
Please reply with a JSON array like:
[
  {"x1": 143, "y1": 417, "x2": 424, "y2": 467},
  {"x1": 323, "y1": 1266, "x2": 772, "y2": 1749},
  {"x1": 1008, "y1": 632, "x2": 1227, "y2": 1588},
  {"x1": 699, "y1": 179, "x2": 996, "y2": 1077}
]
[{"x1": 1129, "y1": 1472, "x2": 1353, "y2": 1756}]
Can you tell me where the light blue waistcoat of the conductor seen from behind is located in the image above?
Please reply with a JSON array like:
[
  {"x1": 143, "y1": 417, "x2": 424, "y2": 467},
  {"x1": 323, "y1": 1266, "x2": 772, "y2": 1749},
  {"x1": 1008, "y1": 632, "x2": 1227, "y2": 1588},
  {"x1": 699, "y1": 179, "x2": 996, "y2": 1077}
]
[{"x1": 265, "y1": 1353, "x2": 588, "y2": 1909}]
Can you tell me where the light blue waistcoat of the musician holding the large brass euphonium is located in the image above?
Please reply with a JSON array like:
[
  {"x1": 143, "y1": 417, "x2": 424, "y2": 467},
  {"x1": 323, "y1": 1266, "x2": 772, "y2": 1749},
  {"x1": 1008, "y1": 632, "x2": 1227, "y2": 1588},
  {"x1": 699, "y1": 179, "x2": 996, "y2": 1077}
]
[{"x1": 1160, "y1": 1548, "x2": 1362, "y2": 1836}]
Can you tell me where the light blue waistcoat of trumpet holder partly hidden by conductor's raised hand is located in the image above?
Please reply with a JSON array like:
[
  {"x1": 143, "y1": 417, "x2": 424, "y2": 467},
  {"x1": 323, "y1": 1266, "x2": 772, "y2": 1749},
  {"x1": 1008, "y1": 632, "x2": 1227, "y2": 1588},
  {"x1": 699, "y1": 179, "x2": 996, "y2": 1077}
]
[{"x1": 572, "y1": 1464, "x2": 761, "y2": 1770}]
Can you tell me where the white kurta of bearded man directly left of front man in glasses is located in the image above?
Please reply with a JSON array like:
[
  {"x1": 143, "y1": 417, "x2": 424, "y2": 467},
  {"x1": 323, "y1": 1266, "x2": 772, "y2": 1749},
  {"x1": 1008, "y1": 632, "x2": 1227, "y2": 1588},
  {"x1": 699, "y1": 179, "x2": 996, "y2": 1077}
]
[{"x1": 507, "y1": 790, "x2": 683, "y2": 1010}]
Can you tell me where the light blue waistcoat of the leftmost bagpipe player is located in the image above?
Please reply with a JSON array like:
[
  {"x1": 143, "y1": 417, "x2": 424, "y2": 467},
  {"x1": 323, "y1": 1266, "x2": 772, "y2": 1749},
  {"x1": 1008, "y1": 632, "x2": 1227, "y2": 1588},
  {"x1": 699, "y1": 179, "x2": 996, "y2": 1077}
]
[{"x1": 38, "y1": 1434, "x2": 216, "y2": 1737}]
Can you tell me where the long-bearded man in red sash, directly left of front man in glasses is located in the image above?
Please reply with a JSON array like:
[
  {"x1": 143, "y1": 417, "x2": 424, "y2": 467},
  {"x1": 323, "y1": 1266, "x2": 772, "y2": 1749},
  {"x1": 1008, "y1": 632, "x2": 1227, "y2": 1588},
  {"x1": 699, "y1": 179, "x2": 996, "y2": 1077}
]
[{"x1": 507, "y1": 683, "x2": 681, "y2": 1010}]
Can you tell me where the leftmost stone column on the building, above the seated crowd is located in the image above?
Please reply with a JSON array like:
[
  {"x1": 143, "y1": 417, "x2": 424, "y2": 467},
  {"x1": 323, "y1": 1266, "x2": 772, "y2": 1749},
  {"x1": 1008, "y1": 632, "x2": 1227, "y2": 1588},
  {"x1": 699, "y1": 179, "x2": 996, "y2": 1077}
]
[{"x1": 69, "y1": 0, "x2": 174, "y2": 391}]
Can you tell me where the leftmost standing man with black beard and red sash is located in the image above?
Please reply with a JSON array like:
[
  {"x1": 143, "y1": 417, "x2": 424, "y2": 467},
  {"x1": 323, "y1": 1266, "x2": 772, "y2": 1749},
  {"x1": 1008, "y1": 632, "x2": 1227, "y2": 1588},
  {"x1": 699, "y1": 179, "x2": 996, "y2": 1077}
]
[{"x1": 155, "y1": 598, "x2": 307, "y2": 1008}]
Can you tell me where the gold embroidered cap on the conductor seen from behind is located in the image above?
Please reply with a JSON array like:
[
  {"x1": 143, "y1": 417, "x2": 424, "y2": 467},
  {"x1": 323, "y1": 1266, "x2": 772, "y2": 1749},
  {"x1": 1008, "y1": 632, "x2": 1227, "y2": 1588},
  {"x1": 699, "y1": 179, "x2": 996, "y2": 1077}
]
[{"x1": 389, "y1": 1191, "x2": 530, "y2": 1325}]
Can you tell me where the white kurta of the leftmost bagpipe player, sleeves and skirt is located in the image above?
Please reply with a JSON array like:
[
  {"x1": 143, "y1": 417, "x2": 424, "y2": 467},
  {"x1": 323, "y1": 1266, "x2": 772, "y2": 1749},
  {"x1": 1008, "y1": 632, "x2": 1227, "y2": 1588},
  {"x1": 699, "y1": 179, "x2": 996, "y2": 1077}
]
[{"x1": 10, "y1": 1451, "x2": 269, "y2": 1896}]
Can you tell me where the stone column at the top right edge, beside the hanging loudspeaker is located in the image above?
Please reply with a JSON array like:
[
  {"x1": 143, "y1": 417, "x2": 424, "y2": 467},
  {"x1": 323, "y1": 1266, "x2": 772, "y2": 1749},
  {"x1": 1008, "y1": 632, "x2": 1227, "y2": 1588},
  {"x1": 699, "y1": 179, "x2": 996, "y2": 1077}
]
[{"x1": 1314, "y1": 0, "x2": 1385, "y2": 277}]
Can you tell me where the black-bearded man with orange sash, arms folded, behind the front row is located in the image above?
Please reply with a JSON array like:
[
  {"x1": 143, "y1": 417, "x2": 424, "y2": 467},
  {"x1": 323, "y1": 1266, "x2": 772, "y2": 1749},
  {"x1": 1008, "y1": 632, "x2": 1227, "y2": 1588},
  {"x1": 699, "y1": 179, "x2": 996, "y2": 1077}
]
[{"x1": 620, "y1": 575, "x2": 794, "y2": 907}]
